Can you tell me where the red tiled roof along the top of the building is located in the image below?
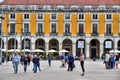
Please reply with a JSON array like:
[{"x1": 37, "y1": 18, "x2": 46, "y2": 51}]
[{"x1": 0, "y1": 0, "x2": 120, "y2": 5}]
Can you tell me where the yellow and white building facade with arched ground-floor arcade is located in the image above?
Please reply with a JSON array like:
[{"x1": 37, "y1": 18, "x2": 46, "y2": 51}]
[{"x1": 0, "y1": 0, "x2": 120, "y2": 58}]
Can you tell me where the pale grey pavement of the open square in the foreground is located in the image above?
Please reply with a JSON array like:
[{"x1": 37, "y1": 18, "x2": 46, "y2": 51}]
[{"x1": 0, "y1": 60, "x2": 120, "y2": 80}]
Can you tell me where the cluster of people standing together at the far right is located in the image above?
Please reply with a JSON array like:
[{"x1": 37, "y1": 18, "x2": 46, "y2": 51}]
[{"x1": 104, "y1": 52, "x2": 119, "y2": 69}]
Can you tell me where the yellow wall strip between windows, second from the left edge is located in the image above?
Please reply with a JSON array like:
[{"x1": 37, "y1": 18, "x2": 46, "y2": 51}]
[{"x1": 16, "y1": 13, "x2": 23, "y2": 34}]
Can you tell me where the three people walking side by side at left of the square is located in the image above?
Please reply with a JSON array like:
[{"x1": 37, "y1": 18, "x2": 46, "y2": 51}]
[{"x1": 12, "y1": 52, "x2": 41, "y2": 74}]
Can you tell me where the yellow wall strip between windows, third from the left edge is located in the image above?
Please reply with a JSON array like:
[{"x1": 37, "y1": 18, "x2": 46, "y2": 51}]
[{"x1": 30, "y1": 13, "x2": 37, "y2": 34}]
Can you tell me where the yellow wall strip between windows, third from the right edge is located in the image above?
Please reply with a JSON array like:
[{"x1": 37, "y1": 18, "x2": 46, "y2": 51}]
[{"x1": 85, "y1": 13, "x2": 92, "y2": 34}]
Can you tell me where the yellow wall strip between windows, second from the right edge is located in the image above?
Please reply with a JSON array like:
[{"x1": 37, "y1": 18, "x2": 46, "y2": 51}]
[{"x1": 98, "y1": 13, "x2": 105, "y2": 35}]
